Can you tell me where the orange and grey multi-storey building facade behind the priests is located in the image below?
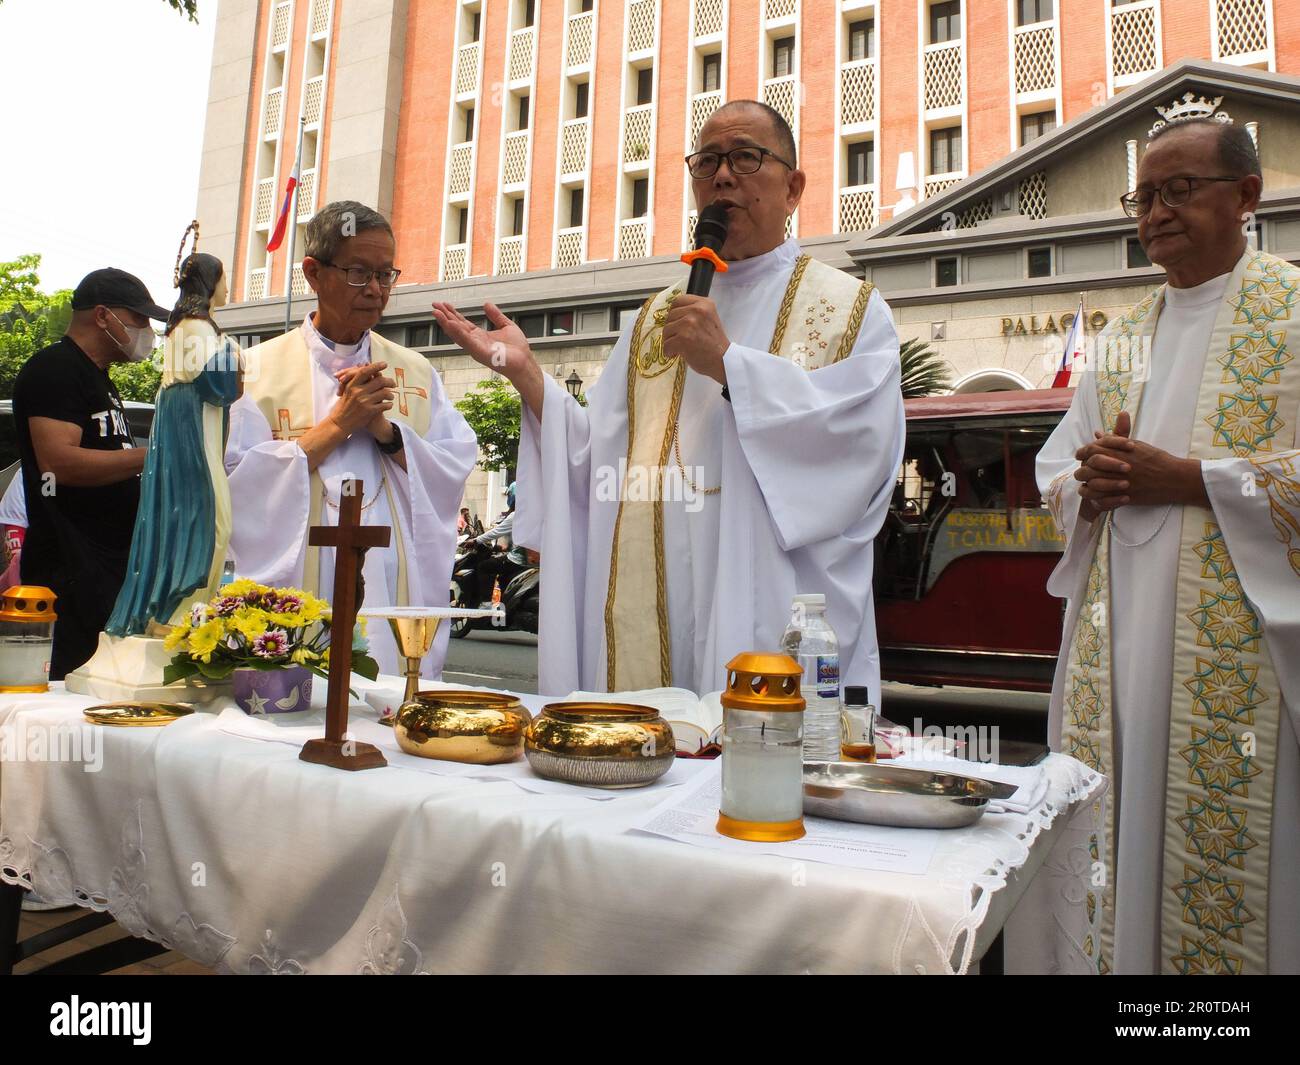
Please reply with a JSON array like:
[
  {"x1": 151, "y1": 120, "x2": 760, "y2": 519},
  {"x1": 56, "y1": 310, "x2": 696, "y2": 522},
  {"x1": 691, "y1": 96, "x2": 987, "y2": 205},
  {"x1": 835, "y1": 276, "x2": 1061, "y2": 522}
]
[{"x1": 198, "y1": 0, "x2": 1300, "y2": 510}]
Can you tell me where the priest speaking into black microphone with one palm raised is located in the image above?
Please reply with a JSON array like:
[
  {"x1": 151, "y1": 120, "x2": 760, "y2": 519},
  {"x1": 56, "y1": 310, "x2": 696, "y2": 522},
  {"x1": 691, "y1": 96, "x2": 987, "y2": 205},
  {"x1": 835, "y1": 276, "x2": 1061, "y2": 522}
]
[{"x1": 434, "y1": 100, "x2": 904, "y2": 694}]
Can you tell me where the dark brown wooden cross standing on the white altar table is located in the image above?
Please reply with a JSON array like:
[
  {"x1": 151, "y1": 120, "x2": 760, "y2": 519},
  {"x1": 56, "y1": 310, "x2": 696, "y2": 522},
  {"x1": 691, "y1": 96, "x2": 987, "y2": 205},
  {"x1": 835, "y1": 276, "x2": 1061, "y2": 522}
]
[{"x1": 299, "y1": 477, "x2": 393, "y2": 770}]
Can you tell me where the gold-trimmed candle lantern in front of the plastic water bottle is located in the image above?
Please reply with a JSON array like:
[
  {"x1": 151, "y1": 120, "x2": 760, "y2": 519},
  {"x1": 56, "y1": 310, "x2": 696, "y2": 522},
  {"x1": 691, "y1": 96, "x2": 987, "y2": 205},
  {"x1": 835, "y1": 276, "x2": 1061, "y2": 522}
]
[{"x1": 718, "y1": 651, "x2": 805, "y2": 843}]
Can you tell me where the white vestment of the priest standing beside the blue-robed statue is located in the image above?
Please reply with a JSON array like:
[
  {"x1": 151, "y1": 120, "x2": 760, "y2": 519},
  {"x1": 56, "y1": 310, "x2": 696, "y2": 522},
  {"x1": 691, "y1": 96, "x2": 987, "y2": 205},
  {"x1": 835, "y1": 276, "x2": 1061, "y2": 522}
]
[{"x1": 226, "y1": 317, "x2": 477, "y2": 677}]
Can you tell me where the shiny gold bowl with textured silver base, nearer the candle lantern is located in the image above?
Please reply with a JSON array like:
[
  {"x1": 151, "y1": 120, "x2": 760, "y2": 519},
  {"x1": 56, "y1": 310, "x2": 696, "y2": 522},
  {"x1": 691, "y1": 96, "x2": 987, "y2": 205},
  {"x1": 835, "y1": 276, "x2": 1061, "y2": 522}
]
[{"x1": 524, "y1": 702, "x2": 676, "y2": 788}]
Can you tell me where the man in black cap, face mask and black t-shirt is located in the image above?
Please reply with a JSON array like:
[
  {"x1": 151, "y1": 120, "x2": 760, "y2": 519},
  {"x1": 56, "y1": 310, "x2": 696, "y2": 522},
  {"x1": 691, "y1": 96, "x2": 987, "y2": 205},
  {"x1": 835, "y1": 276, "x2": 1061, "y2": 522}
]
[{"x1": 13, "y1": 269, "x2": 168, "y2": 680}]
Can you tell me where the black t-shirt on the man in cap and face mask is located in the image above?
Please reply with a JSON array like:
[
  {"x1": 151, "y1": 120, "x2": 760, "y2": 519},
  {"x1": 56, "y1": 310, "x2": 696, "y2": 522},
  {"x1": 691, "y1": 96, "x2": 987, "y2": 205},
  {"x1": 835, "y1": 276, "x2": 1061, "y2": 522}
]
[{"x1": 13, "y1": 337, "x2": 140, "y2": 584}]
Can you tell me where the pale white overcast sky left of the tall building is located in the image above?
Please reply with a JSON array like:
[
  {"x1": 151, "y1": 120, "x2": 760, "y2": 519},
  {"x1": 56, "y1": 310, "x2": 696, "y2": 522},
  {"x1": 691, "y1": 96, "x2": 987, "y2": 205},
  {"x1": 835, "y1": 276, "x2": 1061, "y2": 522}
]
[{"x1": 0, "y1": 0, "x2": 217, "y2": 307}]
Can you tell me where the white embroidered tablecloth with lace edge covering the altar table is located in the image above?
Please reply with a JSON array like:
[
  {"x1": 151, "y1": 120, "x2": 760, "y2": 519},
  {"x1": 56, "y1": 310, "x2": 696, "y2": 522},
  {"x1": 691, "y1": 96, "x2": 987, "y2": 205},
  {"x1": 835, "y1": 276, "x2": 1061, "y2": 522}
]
[{"x1": 0, "y1": 679, "x2": 1105, "y2": 974}]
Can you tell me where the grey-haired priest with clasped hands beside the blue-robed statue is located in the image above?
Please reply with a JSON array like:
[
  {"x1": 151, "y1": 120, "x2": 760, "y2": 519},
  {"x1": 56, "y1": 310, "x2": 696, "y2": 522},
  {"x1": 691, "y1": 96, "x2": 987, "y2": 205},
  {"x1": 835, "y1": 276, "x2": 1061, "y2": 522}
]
[{"x1": 226, "y1": 200, "x2": 477, "y2": 676}]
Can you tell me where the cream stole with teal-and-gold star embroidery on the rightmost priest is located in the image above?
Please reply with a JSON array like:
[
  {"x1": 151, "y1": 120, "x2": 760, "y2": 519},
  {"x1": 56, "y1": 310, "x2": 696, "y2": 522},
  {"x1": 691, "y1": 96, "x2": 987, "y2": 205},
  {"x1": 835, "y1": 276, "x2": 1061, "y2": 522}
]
[{"x1": 1062, "y1": 252, "x2": 1300, "y2": 973}]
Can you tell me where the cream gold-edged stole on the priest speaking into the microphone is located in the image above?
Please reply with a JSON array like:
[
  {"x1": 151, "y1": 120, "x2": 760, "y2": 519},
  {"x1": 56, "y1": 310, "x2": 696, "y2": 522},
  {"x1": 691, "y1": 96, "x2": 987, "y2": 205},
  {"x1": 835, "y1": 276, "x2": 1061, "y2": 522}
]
[{"x1": 605, "y1": 255, "x2": 872, "y2": 692}]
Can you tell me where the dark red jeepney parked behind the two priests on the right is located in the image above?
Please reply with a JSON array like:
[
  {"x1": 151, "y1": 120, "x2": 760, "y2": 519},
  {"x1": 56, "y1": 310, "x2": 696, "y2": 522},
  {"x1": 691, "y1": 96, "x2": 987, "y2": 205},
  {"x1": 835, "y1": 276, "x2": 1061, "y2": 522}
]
[{"x1": 875, "y1": 389, "x2": 1074, "y2": 692}]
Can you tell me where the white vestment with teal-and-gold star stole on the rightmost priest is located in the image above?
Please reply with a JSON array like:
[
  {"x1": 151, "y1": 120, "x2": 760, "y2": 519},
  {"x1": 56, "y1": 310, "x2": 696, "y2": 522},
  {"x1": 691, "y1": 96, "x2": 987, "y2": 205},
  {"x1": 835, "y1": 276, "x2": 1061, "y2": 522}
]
[{"x1": 1024, "y1": 252, "x2": 1300, "y2": 973}]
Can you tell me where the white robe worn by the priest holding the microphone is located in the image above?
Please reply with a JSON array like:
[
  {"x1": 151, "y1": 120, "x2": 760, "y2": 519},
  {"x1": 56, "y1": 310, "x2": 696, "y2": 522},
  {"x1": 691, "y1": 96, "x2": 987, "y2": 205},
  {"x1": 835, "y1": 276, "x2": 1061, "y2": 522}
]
[{"x1": 515, "y1": 241, "x2": 904, "y2": 698}]
